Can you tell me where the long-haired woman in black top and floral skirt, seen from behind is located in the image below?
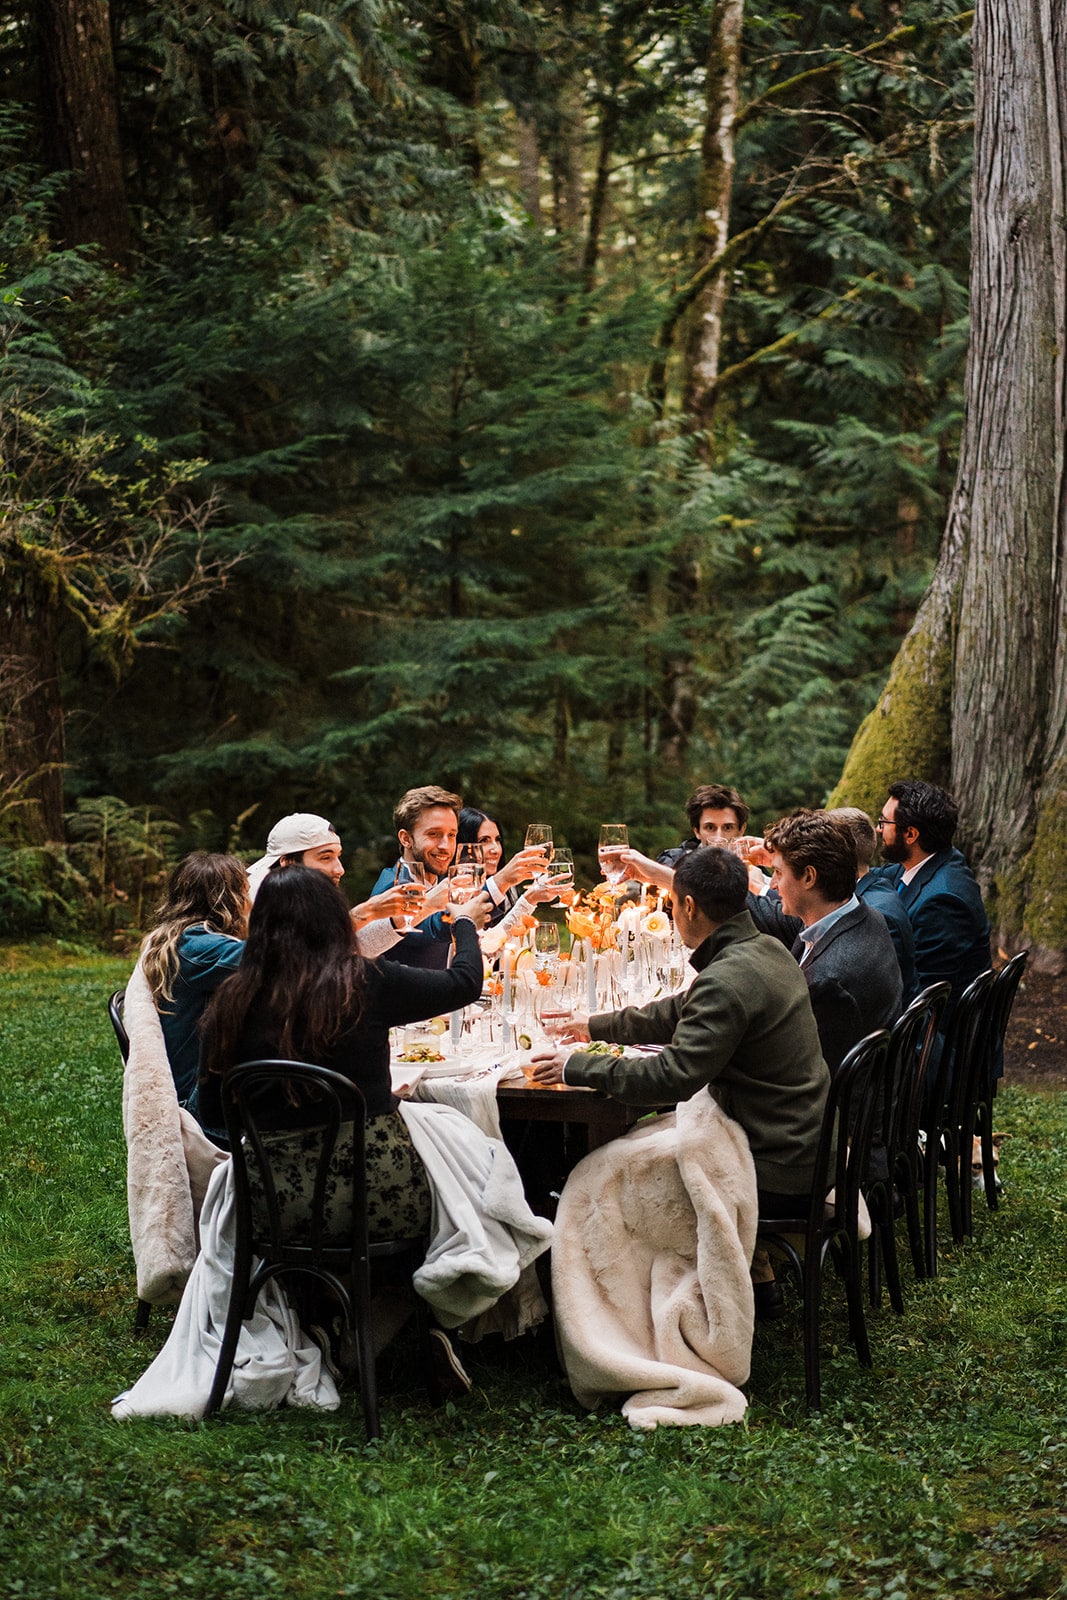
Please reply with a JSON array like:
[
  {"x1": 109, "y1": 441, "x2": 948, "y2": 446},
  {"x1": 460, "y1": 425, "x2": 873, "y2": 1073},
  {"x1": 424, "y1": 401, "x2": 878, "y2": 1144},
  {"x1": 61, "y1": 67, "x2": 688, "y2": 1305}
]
[{"x1": 200, "y1": 866, "x2": 482, "y2": 1238}]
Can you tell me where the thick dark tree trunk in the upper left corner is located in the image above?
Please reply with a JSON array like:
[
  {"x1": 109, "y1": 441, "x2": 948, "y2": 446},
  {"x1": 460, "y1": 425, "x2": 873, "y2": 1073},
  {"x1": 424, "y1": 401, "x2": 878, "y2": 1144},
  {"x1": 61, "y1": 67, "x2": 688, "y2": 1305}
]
[{"x1": 35, "y1": 0, "x2": 131, "y2": 267}]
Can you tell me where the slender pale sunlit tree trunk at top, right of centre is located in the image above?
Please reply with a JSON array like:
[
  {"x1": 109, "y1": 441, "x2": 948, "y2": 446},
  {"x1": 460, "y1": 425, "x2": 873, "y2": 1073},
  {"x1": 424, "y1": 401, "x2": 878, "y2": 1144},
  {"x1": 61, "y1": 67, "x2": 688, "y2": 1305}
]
[{"x1": 681, "y1": 0, "x2": 744, "y2": 430}]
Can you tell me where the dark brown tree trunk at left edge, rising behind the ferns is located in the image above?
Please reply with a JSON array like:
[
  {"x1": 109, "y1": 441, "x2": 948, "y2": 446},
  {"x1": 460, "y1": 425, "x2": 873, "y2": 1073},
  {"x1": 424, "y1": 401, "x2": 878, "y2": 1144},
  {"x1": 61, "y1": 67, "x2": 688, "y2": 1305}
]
[{"x1": 0, "y1": 556, "x2": 64, "y2": 845}]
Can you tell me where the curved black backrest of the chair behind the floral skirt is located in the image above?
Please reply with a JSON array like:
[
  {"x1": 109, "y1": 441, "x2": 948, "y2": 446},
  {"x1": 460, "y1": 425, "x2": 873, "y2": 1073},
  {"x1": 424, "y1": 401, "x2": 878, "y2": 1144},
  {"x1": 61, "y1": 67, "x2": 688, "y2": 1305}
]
[{"x1": 222, "y1": 1061, "x2": 366, "y2": 1266}]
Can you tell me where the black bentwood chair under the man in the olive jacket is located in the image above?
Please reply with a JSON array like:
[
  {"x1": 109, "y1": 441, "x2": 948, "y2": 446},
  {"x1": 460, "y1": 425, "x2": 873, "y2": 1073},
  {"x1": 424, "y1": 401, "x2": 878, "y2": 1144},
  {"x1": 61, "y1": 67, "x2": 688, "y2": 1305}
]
[{"x1": 757, "y1": 1029, "x2": 889, "y2": 1411}]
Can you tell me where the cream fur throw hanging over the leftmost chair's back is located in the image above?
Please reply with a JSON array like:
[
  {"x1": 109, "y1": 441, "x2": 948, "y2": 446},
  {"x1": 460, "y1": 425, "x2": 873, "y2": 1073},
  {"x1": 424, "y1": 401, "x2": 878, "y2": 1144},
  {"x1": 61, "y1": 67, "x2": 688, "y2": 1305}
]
[{"x1": 122, "y1": 963, "x2": 229, "y2": 1306}]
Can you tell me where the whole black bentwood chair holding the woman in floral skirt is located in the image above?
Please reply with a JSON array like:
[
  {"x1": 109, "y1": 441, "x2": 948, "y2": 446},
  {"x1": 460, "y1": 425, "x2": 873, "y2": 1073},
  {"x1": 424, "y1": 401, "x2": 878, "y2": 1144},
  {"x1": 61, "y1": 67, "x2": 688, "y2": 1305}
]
[{"x1": 205, "y1": 1061, "x2": 435, "y2": 1438}]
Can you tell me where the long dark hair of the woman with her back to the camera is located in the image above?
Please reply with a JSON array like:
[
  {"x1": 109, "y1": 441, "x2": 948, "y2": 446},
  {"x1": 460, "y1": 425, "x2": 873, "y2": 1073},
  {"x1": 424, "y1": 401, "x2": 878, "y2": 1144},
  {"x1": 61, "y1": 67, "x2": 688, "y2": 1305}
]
[{"x1": 203, "y1": 867, "x2": 366, "y2": 1072}]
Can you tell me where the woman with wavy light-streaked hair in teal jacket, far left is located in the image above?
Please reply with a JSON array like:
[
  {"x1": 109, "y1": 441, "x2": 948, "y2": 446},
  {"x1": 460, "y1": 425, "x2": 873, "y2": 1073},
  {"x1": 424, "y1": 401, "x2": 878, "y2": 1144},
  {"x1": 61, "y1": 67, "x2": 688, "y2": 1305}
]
[{"x1": 141, "y1": 850, "x2": 250, "y2": 1114}]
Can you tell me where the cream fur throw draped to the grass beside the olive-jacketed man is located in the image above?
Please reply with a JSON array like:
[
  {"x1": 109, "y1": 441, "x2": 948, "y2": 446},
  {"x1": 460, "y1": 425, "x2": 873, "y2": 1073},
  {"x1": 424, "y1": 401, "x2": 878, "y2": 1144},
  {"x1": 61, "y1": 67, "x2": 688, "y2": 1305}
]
[{"x1": 552, "y1": 1090, "x2": 757, "y2": 1429}]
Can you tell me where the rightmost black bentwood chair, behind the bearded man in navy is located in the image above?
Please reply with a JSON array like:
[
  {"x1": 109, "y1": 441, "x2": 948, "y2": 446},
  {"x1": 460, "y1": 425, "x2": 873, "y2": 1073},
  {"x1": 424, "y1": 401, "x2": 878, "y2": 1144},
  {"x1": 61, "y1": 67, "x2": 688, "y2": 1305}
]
[{"x1": 923, "y1": 970, "x2": 993, "y2": 1278}]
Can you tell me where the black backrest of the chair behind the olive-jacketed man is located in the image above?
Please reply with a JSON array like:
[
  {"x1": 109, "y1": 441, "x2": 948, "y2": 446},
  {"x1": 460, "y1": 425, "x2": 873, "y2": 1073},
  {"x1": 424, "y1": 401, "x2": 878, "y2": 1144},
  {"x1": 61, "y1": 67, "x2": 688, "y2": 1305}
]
[{"x1": 805, "y1": 1027, "x2": 889, "y2": 1251}]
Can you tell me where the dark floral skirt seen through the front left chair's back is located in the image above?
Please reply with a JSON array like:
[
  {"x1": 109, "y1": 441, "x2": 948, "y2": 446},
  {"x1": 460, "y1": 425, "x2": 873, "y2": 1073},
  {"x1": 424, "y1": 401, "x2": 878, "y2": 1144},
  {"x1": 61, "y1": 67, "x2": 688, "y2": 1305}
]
[{"x1": 248, "y1": 1112, "x2": 430, "y2": 1245}]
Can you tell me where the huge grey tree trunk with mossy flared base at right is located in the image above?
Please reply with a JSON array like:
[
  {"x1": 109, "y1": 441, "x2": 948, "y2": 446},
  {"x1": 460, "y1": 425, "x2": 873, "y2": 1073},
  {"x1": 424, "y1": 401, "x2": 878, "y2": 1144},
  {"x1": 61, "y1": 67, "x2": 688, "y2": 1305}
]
[{"x1": 833, "y1": 0, "x2": 1067, "y2": 960}]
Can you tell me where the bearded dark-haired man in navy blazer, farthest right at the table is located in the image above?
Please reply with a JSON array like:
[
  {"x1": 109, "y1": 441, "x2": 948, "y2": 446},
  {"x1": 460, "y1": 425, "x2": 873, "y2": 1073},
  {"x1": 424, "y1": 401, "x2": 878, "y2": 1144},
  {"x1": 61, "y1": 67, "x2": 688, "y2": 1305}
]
[{"x1": 877, "y1": 778, "x2": 990, "y2": 1005}]
